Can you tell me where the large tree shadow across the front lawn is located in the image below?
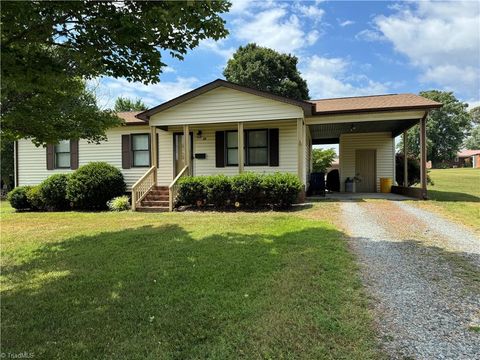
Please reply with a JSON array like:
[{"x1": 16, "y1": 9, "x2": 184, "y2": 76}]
[{"x1": 1, "y1": 225, "x2": 369, "y2": 359}]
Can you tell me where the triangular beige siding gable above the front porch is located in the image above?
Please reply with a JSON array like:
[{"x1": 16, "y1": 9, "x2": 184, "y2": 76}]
[{"x1": 150, "y1": 87, "x2": 303, "y2": 126}]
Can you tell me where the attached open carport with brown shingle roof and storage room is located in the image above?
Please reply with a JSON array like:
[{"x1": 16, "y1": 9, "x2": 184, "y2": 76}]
[{"x1": 305, "y1": 94, "x2": 442, "y2": 199}]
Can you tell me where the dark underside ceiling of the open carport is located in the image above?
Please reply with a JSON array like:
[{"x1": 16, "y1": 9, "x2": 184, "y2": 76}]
[{"x1": 309, "y1": 119, "x2": 418, "y2": 144}]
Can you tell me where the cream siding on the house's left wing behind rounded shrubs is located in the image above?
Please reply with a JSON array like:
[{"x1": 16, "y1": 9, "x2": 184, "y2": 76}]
[{"x1": 18, "y1": 126, "x2": 150, "y2": 188}]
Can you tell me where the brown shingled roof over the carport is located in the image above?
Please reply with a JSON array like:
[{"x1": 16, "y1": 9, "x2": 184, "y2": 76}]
[{"x1": 311, "y1": 94, "x2": 442, "y2": 115}]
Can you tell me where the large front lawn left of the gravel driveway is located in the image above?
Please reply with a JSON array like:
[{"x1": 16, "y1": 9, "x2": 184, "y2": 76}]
[{"x1": 1, "y1": 203, "x2": 379, "y2": 359}]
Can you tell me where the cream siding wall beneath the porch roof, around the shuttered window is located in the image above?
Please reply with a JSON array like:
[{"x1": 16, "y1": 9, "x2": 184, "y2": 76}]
[{"x1": 158, "y1": 120, "x2": 297, "y2": 185}]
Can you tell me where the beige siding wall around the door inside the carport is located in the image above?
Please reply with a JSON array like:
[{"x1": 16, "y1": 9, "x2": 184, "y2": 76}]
[{"x1": 340, "y1": 132, "x2": 395, "y2": 191}]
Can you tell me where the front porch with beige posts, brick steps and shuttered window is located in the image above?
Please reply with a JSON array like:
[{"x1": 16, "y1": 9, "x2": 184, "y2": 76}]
[{"x1": 132, "y1": 118, "x2": 308, "y2": 211}]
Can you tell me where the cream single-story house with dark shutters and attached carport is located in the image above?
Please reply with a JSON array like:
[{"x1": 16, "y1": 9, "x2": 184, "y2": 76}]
[{"x1": 15, "y1": 80, "x2": 441, "y2": 207}]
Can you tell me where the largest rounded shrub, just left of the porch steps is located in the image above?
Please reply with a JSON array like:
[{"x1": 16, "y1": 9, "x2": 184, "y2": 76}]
[{"x1": 66, "y1": 162, "x2": 126, "y2": 210}]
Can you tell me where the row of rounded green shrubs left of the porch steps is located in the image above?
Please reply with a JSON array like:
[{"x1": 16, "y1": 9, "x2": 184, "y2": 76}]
[{"x1": 7, "y1": 162, "x2": 126, "y2": 211}]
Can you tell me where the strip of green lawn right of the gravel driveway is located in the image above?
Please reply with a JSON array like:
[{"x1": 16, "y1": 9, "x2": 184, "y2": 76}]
[{"x1": 425, "y1": 168, "x2": 480, "y2": 230}]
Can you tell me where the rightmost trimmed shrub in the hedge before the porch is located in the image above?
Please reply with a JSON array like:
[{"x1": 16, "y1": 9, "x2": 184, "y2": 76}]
[{"x1": 263, "y1": 173, "x2": 302, "y2": 208}]
